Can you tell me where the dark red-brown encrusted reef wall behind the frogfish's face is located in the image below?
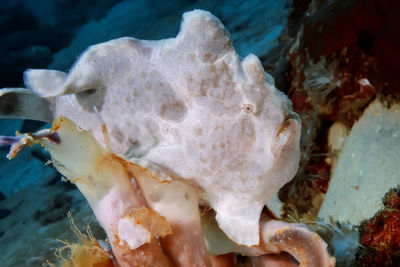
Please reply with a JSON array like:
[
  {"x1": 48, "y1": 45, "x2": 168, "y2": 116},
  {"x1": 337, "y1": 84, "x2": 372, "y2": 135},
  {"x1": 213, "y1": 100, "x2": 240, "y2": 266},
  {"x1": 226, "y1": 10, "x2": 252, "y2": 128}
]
[{"x1": 280, "y1": 0, "x2": 400, "y2": 224}]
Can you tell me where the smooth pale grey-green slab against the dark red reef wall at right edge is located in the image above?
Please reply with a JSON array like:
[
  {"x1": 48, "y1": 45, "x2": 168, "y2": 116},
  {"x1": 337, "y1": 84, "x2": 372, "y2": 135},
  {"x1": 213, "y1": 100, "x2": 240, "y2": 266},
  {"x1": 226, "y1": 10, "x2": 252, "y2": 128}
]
[{"x1": 318, "y1": 100, "x2": 400, "y2": 225}]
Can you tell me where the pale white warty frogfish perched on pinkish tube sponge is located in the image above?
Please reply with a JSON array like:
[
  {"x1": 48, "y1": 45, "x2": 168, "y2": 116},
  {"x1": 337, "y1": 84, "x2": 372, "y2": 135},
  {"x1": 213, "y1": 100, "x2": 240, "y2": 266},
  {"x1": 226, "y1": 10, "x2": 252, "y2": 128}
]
[{"x1": 21, "y1": 10, "x2": 300, "y2": 246}]
